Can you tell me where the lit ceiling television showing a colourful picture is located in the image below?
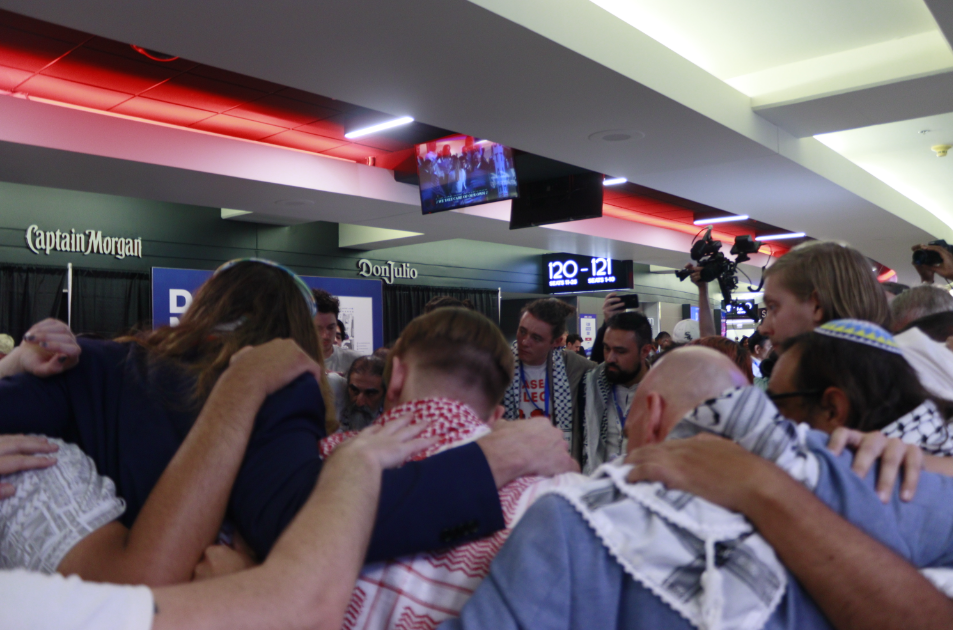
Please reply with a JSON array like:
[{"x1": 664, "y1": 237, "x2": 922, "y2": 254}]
[{"x1": 417, "y1": 135, "x2": 519, "y2": 214}]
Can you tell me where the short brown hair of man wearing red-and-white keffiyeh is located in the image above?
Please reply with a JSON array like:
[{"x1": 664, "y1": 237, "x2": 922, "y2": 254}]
[{"x1": 384, "y1": 307, "x2": 514, "y2": 418}]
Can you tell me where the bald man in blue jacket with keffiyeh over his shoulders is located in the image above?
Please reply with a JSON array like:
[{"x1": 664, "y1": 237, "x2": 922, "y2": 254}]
[{"x1": 441, "y1": 347, "x2": 953, "y2": 630}]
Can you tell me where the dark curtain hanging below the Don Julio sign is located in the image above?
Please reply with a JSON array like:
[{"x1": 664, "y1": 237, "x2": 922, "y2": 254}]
[{"x1": 384, "y1": 284, "x2": 500, "y2": 343}]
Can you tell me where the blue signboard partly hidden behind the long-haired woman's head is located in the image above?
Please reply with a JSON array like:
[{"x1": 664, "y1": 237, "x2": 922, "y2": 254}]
[{"x1": 152, "y1": 267, "x2": 384, "y2": 354}]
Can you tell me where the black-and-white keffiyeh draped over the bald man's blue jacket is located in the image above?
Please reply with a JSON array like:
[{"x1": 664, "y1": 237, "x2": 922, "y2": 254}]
[{"x1": 551, "y1": 387, "x2": 820, "y2": 630}]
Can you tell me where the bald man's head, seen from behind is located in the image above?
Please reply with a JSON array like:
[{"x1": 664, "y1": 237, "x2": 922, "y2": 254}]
[{"x1": 626, "y1": 346, "x2": 750, "y2": 449}]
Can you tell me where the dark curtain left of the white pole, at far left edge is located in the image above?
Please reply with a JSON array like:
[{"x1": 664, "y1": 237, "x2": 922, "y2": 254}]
[{"x1": 0, "y1": 265, "x2": 66, "y2": 345}]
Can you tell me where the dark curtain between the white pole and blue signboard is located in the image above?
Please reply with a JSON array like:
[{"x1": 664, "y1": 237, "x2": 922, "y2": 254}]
[{"x1": 70, "y1": 268, "x2": 152, "y2": 339}]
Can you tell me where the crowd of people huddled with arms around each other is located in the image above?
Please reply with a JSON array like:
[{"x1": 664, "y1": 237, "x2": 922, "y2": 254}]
[{"x1": 0, "y1": 242, "x2": 953, "y2": 630}]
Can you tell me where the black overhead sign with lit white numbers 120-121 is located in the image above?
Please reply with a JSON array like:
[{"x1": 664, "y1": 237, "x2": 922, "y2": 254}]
[{"x1": 543, "y1": 254, "x2": 632, "y2": 293}]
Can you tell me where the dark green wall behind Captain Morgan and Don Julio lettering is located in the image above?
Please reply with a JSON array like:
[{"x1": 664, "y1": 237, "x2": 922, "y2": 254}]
[{"x1": 0, "y1": 182, "x2": 542, "y2": 293}]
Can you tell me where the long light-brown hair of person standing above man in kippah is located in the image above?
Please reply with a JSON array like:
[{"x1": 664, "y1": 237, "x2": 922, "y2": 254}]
[{"x1": 764, "y1": 241, "x2": 890, "y2": 327}]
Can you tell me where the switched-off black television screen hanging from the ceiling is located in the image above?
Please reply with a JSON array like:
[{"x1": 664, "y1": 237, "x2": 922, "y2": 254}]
[{"x1": 510, "y1": 152, "x2": 605, "y2": 230}]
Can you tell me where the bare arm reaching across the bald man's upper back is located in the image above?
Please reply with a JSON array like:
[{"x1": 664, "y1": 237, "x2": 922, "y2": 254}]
[{"x1": 626, "y1": 435, "x2": 953, "y2": 630}]
